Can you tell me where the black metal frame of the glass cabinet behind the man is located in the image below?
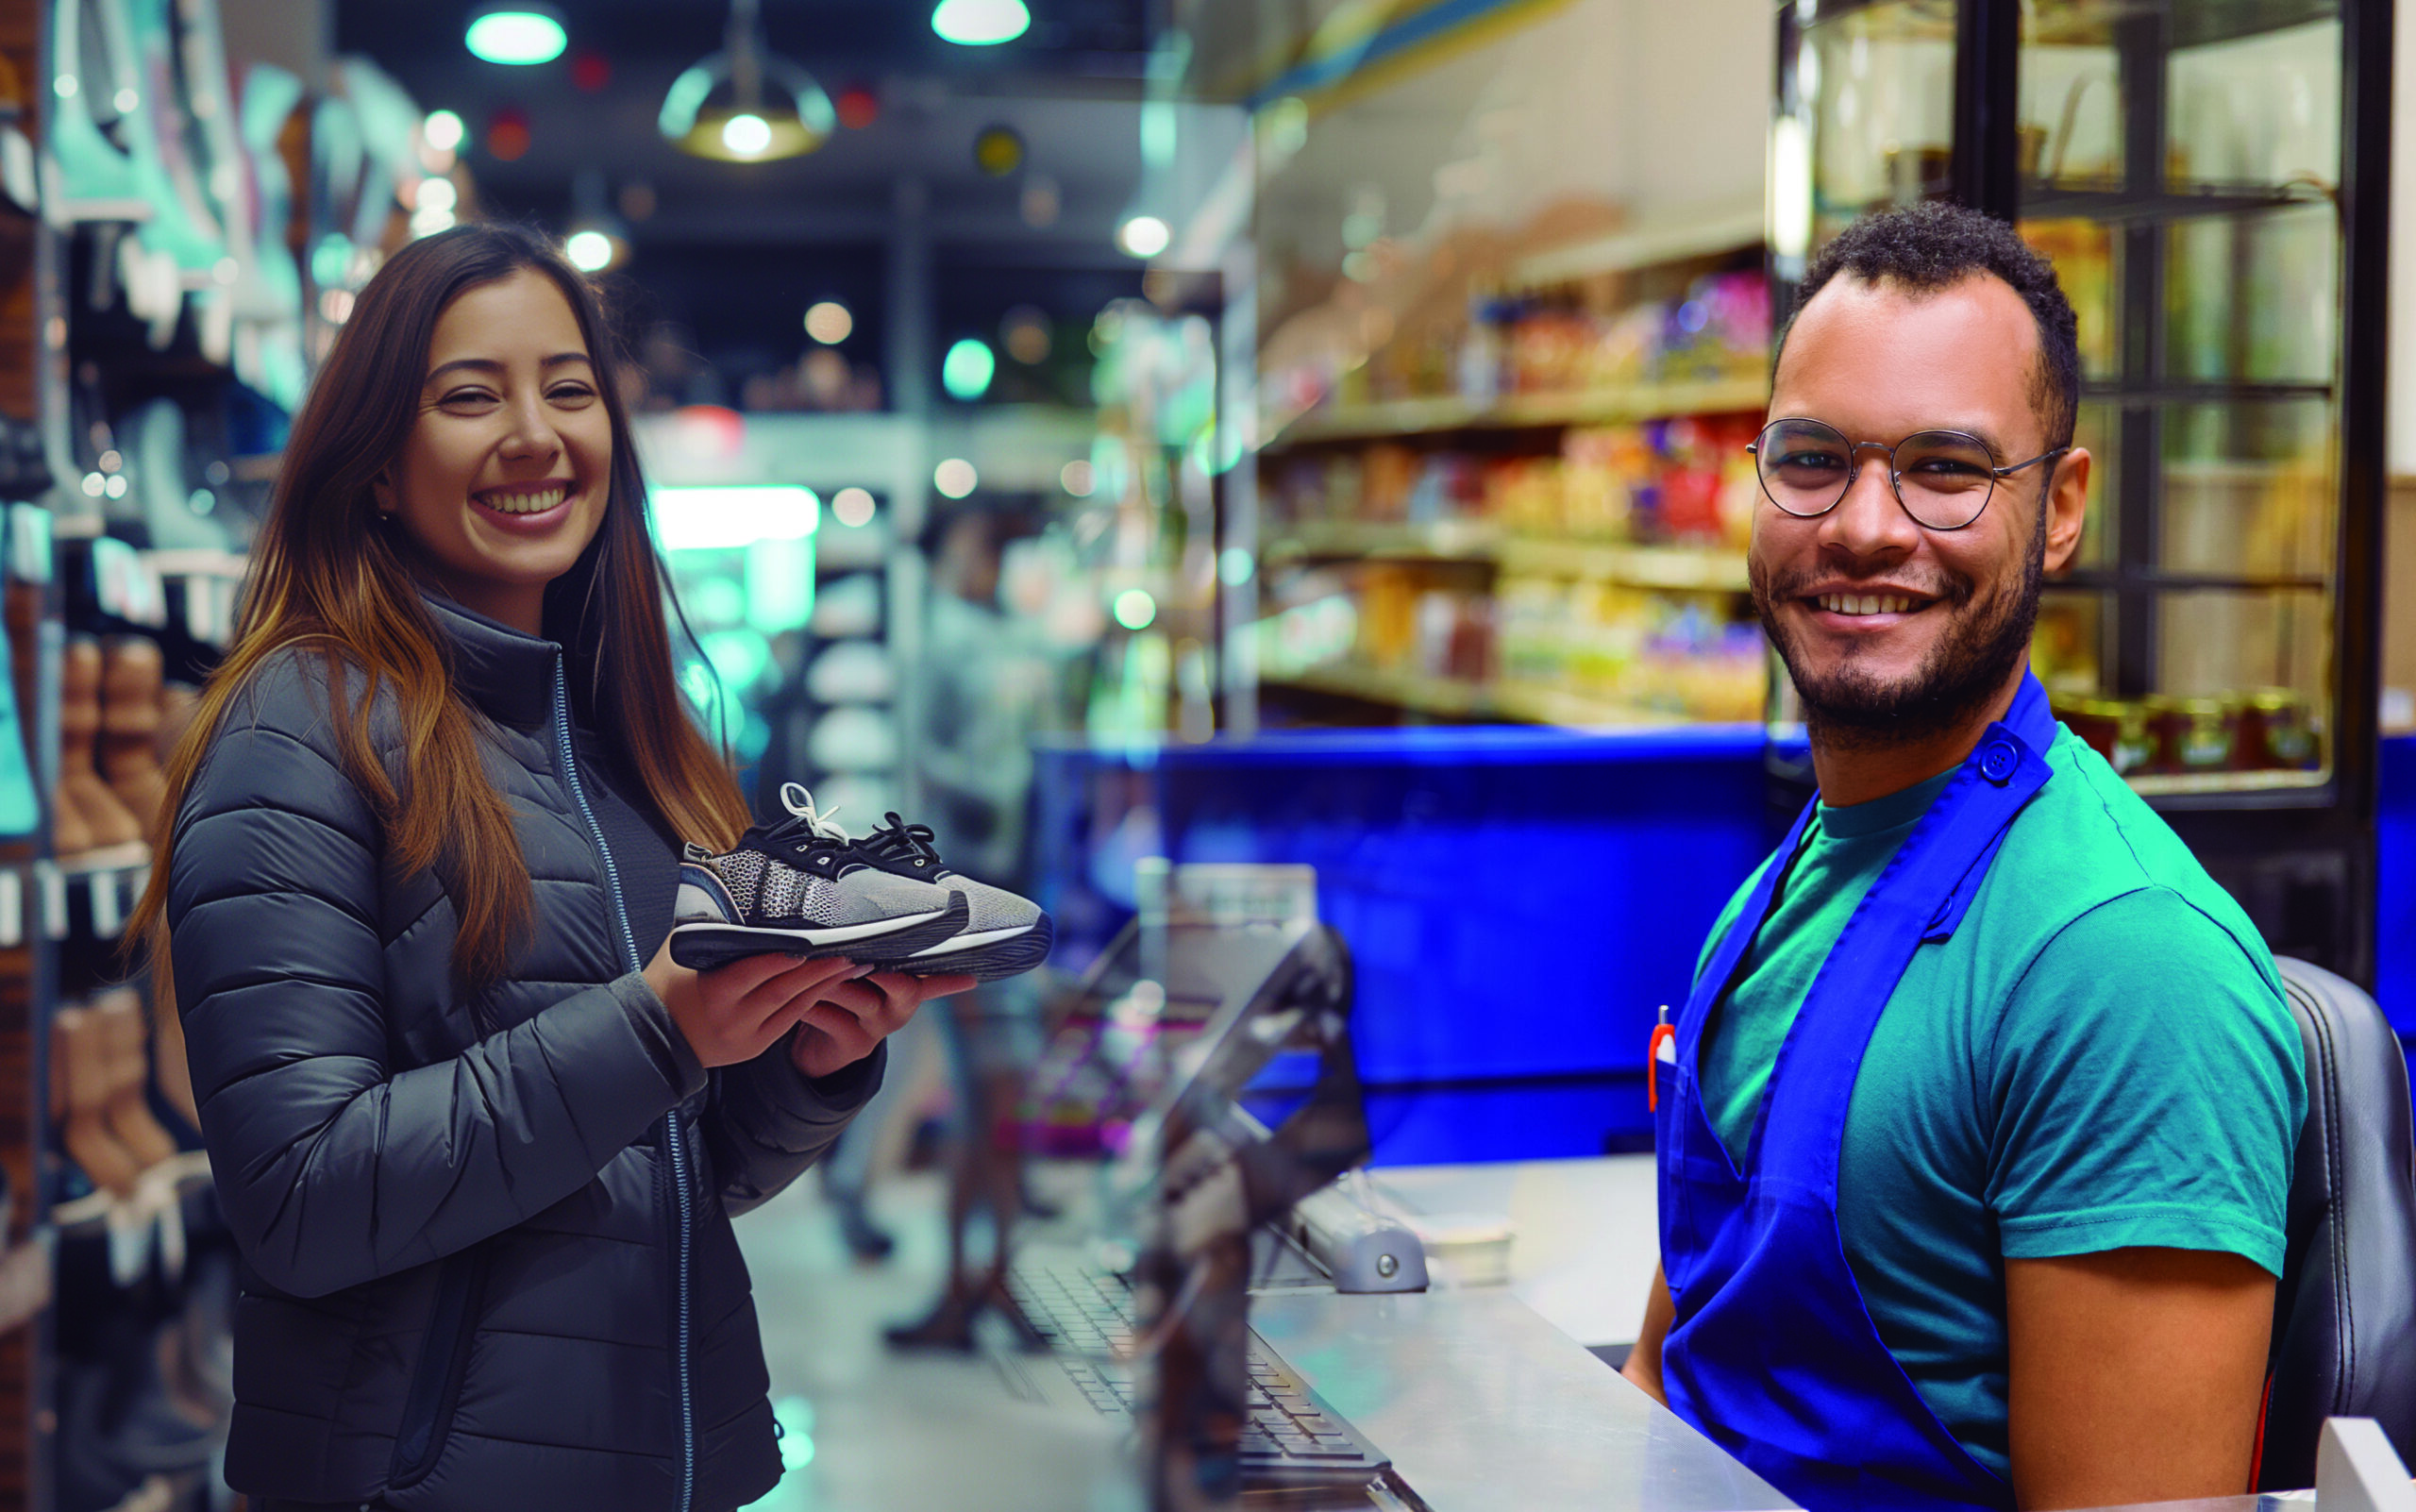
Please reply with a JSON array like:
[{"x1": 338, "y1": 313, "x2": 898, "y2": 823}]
[{"x1": 1770, "y1": 0, "x2": 2391, "y2": 985}]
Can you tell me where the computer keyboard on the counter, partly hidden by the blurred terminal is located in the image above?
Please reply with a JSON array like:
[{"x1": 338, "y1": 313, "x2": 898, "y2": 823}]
[{"x1": 1008, "y1": 1261, "x2": 1389, "y2": 1486}]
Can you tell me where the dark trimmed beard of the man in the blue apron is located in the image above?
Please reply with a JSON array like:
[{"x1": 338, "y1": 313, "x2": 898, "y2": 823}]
[{"x1": 1752, "y1": 507, "x2": 2046, "y2": 747}]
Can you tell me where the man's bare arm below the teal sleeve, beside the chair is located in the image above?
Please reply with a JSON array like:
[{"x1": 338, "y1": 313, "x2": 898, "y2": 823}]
[{"x1": 2009, "y1": 1249, "x2": 2273, "y2": 1512}]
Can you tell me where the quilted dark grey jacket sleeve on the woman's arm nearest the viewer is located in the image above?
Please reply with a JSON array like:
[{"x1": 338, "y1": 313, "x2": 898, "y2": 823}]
[{"x1": 167, "y1": 662, "x2": 706, "y2": 1297}]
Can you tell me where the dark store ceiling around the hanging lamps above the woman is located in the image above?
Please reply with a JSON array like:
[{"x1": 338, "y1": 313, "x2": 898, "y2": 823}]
[{"x1": 333, "y1": 0, "x2": 1150, "y2": 394}]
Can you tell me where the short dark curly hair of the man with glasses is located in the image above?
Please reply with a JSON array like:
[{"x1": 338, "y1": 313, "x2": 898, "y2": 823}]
[{"x1": 1778, "y1": 200, "x2": 2080, "y2": 446}]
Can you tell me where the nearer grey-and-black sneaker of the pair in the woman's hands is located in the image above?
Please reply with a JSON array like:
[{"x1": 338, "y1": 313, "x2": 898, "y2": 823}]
[{"x1": 672, "y1": 782, "x2": 969, "y2": 971}]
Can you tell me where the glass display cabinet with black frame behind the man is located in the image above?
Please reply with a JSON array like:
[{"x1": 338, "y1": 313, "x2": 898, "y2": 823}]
[{"x1": 1770, "y1": 0, "x2": 2391, "y2": 973}]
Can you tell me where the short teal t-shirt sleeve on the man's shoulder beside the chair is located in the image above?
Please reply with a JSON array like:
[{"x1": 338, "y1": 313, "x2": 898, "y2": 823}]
[{"x1": 1988, "y1": 886, "x2": 2307, "y2": 1275}]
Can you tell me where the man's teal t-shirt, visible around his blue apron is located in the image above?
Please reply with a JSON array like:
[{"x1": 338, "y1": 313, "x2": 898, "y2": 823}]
[{"x1": 1696, "y1": 730, "x2": 2307, "y2": 1478}]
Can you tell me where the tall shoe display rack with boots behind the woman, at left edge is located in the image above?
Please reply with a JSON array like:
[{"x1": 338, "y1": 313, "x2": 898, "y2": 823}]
[{"x1": 0, "y1": 0, "x2": 451, "y2": 1512}]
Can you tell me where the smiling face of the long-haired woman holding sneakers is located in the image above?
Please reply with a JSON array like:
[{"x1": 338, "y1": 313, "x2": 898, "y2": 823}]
[{"x1": 377, "y1": 268, "x2": 612, "y2": 635}]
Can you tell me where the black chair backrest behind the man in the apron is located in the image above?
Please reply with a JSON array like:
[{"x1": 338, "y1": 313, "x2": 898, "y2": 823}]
[{"x1": 2257, "y1": 956, "x2": 2416, "y2": 1490}]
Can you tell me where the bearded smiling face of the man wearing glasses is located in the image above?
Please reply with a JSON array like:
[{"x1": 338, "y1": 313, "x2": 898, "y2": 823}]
[{"x1": 1749, "y1": 276, "x2": 2089, "y2": 742}]
